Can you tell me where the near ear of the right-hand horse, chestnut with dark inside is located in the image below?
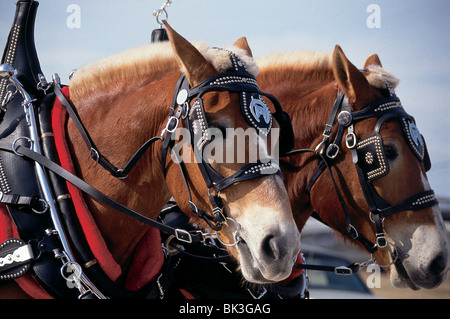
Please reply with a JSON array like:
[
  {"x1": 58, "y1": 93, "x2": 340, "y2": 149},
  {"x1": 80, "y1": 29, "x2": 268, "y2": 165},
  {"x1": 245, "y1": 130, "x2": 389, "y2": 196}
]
[{"x1": 332, "y1": 45, "x2": 371, "y2": 110}]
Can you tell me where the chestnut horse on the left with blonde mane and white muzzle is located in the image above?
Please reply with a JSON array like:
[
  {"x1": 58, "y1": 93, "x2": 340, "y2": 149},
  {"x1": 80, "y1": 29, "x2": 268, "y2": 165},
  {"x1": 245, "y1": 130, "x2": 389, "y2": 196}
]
[{"x1": 0, "y1": 25, "x2": 300, "y2": 296}]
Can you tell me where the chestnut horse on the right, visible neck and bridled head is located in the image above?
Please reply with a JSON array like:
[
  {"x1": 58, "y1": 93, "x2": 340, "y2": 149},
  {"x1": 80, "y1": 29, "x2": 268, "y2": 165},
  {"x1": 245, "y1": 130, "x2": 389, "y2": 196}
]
[{"x1": 257, "y1": 46, "x2": 449, "y2": 289}]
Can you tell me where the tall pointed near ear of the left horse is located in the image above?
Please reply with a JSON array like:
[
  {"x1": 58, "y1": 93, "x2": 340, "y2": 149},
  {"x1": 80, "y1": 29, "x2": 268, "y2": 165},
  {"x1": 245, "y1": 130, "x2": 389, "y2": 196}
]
[{"x1": 163, "y1": 20, "x2": 217, "y2": 86}]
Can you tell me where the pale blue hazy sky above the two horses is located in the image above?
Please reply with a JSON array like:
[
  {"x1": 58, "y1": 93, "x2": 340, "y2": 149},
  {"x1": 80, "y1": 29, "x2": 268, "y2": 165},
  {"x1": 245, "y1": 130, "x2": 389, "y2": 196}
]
[{"x1": 0, "y1": 0, "x2": 450, "y2": 198}]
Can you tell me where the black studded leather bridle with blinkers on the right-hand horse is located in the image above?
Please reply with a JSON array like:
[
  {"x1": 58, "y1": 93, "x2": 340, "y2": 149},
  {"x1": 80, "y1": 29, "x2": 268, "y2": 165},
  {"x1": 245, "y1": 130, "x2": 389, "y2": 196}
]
[{"x1": 287, "y1": 83, "x2": 438, "y2": 253}]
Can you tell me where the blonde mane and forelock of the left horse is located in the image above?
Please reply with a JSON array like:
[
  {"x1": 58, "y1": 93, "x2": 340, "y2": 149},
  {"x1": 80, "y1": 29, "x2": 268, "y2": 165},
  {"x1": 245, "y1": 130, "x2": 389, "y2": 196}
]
[{"x1": 70, "y1": 42, "x2": 258, "y2": 101}]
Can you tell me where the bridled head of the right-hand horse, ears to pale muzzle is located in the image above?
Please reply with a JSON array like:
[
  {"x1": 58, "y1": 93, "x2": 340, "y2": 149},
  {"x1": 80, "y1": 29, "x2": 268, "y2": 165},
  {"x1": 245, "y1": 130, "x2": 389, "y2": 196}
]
[{"x1": 311, "y1": 46, "x2": 449, "y2": 289}]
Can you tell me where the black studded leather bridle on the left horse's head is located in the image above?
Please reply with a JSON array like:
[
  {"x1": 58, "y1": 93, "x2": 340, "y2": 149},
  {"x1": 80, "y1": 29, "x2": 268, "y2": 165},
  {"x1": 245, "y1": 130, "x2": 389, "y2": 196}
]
[{"x1": 161, "y1": 52, "x2": 283, "y2": 230}]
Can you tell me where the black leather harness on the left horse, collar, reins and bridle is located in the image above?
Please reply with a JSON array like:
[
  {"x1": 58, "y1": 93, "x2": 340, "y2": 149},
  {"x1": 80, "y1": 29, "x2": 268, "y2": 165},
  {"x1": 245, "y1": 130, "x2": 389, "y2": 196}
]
[{"x1": 0, "y1": 2, "x2": 292, "y2": 299}]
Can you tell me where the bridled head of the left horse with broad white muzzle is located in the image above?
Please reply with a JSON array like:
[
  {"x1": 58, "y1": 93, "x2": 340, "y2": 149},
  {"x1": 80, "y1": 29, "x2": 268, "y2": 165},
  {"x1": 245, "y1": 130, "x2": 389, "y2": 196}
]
[{"x1": 160, "y1": 23, "x2": 300, "y2": 283}]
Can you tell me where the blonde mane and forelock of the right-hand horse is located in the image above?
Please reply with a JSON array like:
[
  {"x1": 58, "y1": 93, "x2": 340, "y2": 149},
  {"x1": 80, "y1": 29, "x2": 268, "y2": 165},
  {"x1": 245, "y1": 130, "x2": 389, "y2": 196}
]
[{"x1": 256, "y1": 51, "x2": 399, "y2": 89}]
